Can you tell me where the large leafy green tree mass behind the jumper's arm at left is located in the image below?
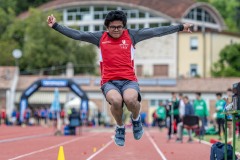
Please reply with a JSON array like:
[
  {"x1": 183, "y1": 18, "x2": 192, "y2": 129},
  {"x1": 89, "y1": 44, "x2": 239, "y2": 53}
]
[{"x1": 2, "y1": 9, "x2": 96, "y2": 74}]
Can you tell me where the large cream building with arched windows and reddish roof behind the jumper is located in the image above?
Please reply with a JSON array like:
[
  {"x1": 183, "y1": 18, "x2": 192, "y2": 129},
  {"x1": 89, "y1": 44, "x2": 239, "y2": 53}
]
[{"x1": 20, "y1": 0, "x2": 240, "y2": 78}]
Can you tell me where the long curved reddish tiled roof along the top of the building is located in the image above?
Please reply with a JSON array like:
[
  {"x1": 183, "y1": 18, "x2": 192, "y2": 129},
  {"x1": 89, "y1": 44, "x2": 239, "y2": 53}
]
[{"x1": 20, "y1": 0, "x2": 196, "y2": 18}]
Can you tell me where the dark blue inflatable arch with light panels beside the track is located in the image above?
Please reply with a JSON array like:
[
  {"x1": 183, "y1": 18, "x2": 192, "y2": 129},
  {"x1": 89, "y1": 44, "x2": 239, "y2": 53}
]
[{"x1": 19, "y1": 79, "x2": 88, "y2": 123}]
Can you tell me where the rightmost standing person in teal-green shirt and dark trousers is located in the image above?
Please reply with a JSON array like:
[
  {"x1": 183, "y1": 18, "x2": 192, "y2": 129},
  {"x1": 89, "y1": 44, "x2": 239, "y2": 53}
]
[{"x1": 215, "y1": 93, "x2": 226, "y2": 140}]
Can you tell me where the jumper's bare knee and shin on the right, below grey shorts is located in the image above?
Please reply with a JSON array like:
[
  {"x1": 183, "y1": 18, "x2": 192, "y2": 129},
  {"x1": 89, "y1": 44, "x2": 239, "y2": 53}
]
[{"x1": 123, "y1": 88, "x2": 141, "y2": 119}]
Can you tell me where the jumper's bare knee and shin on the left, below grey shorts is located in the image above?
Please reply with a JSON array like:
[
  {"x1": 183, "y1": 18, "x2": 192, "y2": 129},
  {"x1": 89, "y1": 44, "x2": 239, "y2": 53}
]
[{"x1": 106, "y1": 89, "x2": 123, "y2": 126}]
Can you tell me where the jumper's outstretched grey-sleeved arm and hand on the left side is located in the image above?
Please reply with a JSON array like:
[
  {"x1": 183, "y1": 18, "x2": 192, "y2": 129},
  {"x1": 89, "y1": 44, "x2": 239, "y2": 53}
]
[{"x1": 47, "y1": 15, "x2": 103, "y2": 46}]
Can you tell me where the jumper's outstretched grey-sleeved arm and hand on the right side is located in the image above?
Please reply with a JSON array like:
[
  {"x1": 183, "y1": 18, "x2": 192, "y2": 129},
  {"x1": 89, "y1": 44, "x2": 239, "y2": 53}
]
[{"x1": 129, "y1": 23, "x2": 192, "y2": 45}]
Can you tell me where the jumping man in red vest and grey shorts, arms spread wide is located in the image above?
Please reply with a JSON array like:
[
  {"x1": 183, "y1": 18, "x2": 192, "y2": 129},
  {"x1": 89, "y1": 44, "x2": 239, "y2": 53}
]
[{"x1": 47, "y1": 10, "x2": 192, "y2": 146}]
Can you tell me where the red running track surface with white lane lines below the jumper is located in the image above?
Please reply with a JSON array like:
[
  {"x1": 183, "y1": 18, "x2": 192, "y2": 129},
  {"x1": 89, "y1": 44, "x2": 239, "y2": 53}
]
[{"x1": 0, "y1": 126, "x2": 227, "y2": 160}]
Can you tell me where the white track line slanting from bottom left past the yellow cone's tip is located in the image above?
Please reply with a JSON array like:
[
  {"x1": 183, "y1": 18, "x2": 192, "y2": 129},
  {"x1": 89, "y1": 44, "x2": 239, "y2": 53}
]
[{"x1": 8, "y1": 133, "x2": 98, "y2": 160}]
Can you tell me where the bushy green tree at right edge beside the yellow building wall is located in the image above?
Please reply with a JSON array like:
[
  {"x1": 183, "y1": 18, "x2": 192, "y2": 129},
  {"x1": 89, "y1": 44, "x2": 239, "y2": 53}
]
[{"x1": 212, "y1": 44, "x2": 240, "y2": 77}]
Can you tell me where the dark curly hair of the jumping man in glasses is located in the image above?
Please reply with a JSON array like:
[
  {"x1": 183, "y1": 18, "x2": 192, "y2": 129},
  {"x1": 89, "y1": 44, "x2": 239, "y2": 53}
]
[{"x1": 104, "y1": 10, "x2": 127, "y2": 27}]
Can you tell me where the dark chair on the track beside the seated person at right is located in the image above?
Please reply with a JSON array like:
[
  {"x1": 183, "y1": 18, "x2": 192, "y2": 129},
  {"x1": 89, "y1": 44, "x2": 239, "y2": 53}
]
[{"x1": 183, "y1": 115, "x2": 201, "y2": 143}]
